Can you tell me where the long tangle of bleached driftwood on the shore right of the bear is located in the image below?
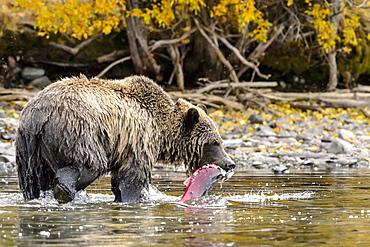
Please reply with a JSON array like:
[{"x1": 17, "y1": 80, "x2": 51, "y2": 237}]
[{"x1": 168, "y1": 81, "x2": 370, "y2": 110}]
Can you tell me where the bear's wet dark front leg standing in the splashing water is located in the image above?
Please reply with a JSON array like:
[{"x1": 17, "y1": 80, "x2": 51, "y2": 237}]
[{"x1": 111, "y1": 167, "x2": 151, "y2": 203}]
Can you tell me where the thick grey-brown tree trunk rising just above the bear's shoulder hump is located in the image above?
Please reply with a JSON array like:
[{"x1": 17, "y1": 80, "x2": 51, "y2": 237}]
[{"x1": 126, "y1": 0, "x2": 161, "y2": 80}]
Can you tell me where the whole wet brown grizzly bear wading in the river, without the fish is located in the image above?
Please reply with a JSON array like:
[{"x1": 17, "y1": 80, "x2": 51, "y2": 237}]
[{"x1": 15, "y1": 76, "x2": 235, "y2": 203}]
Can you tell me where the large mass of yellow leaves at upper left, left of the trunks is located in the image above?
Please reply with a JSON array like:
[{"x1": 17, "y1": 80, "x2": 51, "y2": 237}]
[{"x1": 15, "y1": 0, "x2": 126, "y2": 39}]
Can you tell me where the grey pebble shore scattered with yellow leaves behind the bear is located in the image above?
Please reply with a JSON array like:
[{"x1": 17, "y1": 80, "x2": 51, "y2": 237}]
[{"x1": 0, "y1": 101, "x2": 370, "y2": 174}]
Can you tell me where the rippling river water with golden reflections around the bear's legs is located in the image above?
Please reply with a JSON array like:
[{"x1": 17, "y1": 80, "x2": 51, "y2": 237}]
[{"x1": 0, "y1": 168, "x2": 370, "y2": 246}]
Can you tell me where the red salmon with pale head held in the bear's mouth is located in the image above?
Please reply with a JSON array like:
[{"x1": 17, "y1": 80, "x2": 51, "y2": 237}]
[{"x1": 178, "y1": 164, "x2": 234, "y2": 201}]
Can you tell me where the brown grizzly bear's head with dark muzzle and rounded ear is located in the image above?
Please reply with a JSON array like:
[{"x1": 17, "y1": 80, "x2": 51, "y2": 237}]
[{"x1": 175, "y1": 99, "x2": 235, "y2": 175}]
